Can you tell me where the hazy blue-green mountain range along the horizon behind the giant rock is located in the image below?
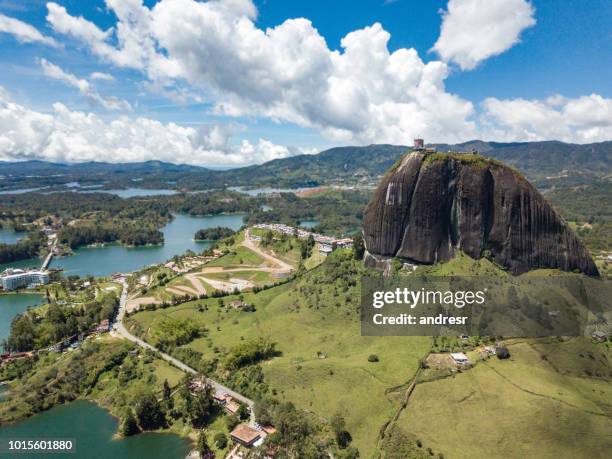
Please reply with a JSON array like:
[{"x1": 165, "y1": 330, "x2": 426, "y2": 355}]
[{"x1": 0, "y1": 140, "x2": 612, "y2": 190}]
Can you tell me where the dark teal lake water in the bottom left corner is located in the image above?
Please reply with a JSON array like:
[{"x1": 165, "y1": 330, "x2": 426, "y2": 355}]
[{"x1": 0, "y1": 401, "x2": 190, "y2": 459}]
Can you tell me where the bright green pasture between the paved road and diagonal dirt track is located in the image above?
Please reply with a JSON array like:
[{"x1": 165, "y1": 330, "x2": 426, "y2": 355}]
[{"x1": 131, "y1": 255, "x2": 431, "y2": 457}]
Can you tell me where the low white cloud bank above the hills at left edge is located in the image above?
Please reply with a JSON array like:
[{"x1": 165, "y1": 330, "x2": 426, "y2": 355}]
[{"x1": 0, "y1": 87, "x2": 299, "y2": 166}]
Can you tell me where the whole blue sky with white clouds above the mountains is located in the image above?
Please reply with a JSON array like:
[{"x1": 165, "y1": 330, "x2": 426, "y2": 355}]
[{"x1": 0, "y1": 0, "x2": 612, "y2": 167}]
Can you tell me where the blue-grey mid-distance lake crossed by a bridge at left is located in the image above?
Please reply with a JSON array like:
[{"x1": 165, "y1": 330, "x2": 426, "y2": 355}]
[{"x1": 0, "y1": 215, "x2": 243, "y2": 276}]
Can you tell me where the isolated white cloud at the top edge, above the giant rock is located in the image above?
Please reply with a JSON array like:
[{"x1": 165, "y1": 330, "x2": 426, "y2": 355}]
[{"x1": 433, "y1": 0, "x2": 536, "y2": 70}]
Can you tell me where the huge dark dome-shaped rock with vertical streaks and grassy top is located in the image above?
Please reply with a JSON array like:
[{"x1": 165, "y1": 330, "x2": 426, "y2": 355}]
[{"x1": 364, "y1": 152, "x2": 598, "y2": 275}]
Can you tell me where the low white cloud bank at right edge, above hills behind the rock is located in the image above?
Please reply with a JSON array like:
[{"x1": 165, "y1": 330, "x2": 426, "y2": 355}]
[{"x1": 480, "y1": 94, "x2": 612, "y2": 143}]
